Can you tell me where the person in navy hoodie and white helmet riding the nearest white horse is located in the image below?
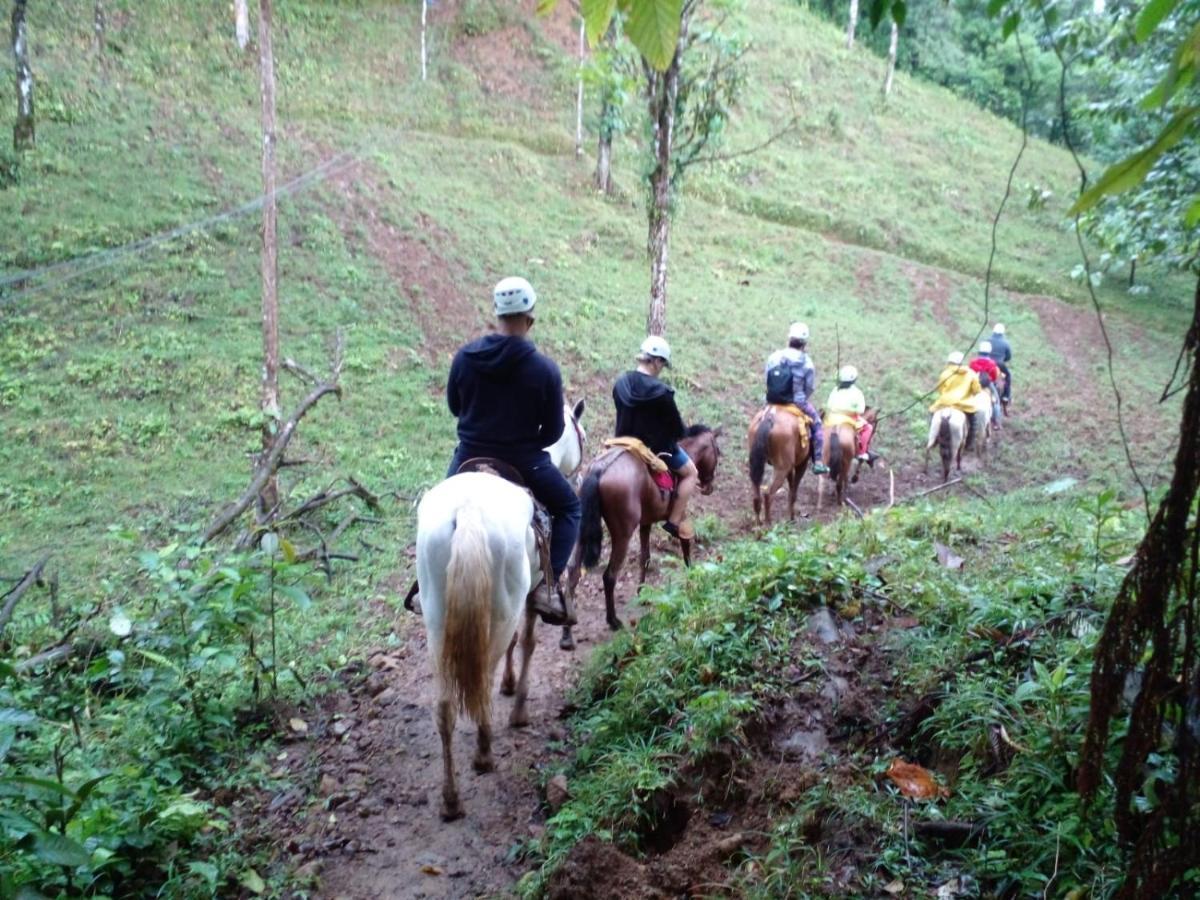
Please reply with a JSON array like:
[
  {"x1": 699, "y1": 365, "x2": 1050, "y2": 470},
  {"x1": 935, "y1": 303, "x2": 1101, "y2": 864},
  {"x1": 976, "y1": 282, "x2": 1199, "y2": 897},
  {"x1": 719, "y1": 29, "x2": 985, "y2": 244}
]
[{"x1": 446, "y1": 277, "x2": 580, "y2": 614}]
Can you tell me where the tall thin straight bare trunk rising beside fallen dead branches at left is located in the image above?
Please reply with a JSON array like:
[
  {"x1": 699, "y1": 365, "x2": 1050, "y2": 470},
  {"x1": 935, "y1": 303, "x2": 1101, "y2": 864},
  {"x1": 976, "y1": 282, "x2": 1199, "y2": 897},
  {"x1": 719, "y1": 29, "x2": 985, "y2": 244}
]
[{"x1": 258, "y1": 0, "x2": 280, "y2": 518}]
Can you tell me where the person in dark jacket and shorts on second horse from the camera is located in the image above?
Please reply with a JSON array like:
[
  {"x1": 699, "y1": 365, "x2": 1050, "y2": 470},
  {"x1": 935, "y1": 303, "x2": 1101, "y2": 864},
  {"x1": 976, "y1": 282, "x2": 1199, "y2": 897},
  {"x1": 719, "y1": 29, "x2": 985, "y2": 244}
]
[{"x1": 612, "y1": 335, "x2": 700, "y2": 538}]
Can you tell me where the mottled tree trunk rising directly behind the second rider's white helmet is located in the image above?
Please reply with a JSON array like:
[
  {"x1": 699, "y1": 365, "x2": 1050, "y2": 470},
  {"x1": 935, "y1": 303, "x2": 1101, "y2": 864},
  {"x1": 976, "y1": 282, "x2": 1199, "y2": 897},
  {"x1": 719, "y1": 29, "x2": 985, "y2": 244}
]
[{"x1": 646, "y1": 50, "x2": 685, "y2": 335}]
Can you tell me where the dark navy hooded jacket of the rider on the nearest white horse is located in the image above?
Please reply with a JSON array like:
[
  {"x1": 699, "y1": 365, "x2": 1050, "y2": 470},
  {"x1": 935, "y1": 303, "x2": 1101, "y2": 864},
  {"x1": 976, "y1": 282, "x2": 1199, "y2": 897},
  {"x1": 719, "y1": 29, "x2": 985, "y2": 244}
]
[{"x1": 446, "y1": 335, "x2": 564, "y2": 466}]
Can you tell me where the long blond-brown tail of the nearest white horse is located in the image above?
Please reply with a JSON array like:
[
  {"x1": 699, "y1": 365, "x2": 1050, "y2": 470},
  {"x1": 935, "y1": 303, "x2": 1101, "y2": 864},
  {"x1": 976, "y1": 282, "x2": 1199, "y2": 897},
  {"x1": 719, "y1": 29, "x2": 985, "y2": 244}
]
[{"x1": 440, "y1": 504, "x2": 492, "y2": 722}]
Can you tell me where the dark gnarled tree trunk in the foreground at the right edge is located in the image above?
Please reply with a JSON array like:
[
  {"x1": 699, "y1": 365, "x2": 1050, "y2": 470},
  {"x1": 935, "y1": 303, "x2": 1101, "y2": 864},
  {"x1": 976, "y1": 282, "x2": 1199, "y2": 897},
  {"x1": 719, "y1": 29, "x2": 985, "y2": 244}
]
[{"x1": 1075, "y1": 282, "x2": 1200, "y2": 899}]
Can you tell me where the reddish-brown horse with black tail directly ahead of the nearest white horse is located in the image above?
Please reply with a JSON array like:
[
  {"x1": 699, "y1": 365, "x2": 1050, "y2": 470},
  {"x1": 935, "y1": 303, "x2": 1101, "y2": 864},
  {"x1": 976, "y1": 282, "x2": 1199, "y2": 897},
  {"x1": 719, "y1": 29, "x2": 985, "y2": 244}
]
[{"x1": 558, "y1": 425, "x2": 721, "y2": 650}]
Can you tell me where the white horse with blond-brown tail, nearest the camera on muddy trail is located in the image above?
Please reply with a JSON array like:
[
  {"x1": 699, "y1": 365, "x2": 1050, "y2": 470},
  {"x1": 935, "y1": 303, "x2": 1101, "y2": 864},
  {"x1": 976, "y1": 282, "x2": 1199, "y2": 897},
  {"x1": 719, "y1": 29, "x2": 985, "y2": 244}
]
[{"x1": 416, "y1": 472, "x2": 540, "y2": 822}]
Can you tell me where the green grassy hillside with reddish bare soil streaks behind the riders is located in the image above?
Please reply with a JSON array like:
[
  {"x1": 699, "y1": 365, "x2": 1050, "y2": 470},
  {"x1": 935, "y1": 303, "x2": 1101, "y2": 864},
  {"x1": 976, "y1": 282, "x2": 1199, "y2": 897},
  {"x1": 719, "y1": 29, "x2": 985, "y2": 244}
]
[{"x1": 0, "y1": 0, "x2": 1187, "y2": 897}]
